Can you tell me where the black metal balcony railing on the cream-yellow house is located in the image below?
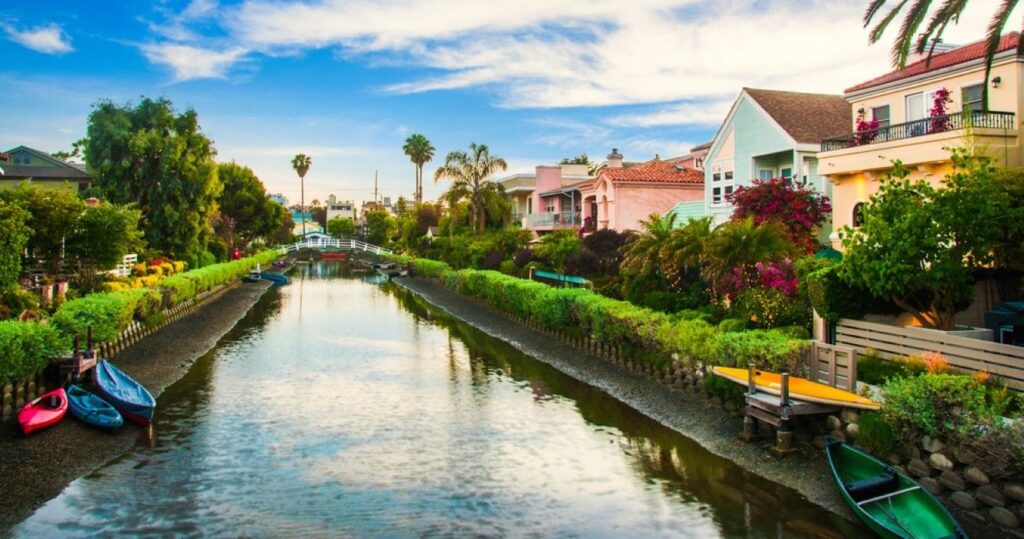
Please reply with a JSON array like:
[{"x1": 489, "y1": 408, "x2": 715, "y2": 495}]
[{"x1": 821, "y1": 111, "x2": 1017, "y2": 152}]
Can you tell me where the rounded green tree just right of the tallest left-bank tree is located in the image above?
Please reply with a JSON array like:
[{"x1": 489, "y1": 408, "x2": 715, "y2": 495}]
[{"x1": 217, "y1": 162, "x2": 287, "y2": 248}]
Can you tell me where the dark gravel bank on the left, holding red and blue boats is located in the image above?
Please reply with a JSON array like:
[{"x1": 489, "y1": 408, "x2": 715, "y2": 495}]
[{"x1": 0, "y1": 281, "x2": 271, "y2": 535}]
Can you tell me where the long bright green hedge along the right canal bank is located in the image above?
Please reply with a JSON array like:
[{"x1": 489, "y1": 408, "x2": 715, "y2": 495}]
[{"x1": 390, "y1": 255, "x2": 806, "y2": 373}]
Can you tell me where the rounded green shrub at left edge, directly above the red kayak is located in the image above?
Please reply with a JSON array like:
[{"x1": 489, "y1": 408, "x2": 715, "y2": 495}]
[{"x1": 0, "y1": 320, "x2": 70, "y2": 384}]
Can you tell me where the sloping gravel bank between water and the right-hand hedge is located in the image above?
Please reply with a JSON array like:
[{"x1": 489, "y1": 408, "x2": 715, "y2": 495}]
[{"x1": 393, "y1": 278, "x2": 1007, "y2": 537}]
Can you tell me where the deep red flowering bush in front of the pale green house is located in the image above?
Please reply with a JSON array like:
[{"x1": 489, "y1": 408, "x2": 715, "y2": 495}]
[{"x1": 728, "y1": 178, "x2": 831, "y2": 253}]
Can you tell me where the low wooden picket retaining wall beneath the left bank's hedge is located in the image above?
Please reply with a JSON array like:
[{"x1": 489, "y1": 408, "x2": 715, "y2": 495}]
[{"x1": 0, "y1": 281, "x2": 240, "y2": 420}]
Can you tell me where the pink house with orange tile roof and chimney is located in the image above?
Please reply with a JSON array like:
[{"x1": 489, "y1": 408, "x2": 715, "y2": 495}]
[{"x1": 581, "y1": 150, "x2": 705, "y2": 232}]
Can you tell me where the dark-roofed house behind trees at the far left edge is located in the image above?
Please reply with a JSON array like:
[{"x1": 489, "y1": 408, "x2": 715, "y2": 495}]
[{"x1": 0, "y1": 146, "x2": 92, "y2": 193}]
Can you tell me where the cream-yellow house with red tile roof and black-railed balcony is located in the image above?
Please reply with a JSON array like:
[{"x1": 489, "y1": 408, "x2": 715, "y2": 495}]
[{"x1": 818, "y1": 33, "x2": 1024, "y2": 249}]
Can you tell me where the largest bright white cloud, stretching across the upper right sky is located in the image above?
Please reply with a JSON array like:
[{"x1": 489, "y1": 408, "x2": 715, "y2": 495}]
[{"x1": 151, "y1": 0, "x2": 1019, "y2": 105}]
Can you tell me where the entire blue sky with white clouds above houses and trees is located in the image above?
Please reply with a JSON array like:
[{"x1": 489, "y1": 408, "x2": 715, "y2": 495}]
[{"x1": 0, "y1": 0, "x2": 1007, "y2": 205}]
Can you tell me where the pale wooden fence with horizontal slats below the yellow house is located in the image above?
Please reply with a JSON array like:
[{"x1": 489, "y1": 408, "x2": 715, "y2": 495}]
[{"x1": 836, "y1": 319, "x2": 1024, "y2": 390}]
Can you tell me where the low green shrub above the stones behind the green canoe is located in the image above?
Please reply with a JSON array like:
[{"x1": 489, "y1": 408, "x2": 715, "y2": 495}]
[{"x1": 882, "y1": 373, "x2": 995, "y2": 441}]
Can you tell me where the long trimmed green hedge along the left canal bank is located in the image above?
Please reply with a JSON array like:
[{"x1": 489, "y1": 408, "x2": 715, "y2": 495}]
[{"x1": 0, "y1": 250, "x2": 279, "y2": 383}]
